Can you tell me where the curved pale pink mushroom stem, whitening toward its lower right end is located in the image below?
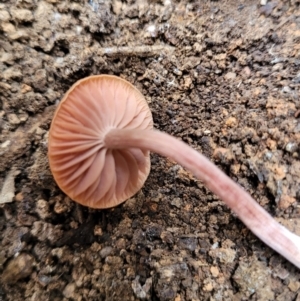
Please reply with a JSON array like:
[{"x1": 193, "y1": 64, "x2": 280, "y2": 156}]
[{"x1": 105, "y1": 129, "x2": 300, "y2": 268}]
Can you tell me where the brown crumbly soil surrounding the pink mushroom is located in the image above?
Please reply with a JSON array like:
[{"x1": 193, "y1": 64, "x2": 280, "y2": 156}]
[{"x1": 0, "y1": 0, "x2": 300, "y2": 301}]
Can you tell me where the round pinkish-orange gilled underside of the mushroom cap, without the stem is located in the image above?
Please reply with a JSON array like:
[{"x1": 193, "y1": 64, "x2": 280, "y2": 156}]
[{"x1": 48, "y1": 75, "x2": 153, "y2": 208}]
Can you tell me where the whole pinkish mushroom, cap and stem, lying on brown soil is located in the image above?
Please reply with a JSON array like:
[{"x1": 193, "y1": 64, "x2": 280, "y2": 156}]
[{"x1": 48, "y1": 75, "x2": 300, "y2": 268}]
